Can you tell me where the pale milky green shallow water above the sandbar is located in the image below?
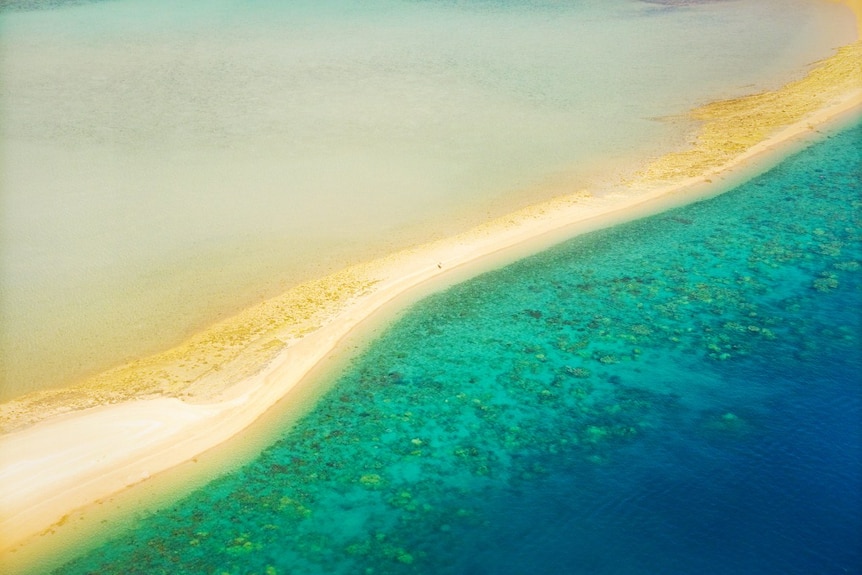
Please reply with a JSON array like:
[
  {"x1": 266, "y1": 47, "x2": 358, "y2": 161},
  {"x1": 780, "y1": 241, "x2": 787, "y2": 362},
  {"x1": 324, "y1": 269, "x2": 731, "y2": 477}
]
[{"x1": 0, "y1": 0, "x2": 853, "y2": 397}]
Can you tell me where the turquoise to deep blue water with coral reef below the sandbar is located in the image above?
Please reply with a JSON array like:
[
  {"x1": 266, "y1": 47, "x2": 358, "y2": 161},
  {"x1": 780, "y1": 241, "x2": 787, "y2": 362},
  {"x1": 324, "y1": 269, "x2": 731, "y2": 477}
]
[{"x1": 49, "y1": 119, "x2": 862, "y2": 575}]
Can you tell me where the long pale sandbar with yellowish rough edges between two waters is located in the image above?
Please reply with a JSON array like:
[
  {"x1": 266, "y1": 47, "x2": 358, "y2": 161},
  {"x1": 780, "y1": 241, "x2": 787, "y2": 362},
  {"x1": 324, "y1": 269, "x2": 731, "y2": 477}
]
[{"x1": 0, "y1": 6, "x2": 862, "y2": 568}]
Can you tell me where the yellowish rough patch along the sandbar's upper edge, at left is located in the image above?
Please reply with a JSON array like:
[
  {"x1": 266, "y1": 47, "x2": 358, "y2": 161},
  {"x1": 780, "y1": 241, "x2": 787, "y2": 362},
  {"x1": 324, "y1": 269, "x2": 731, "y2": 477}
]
[{"x1": 0, "y1": 266, "x2": 376, "y2": 433}]
